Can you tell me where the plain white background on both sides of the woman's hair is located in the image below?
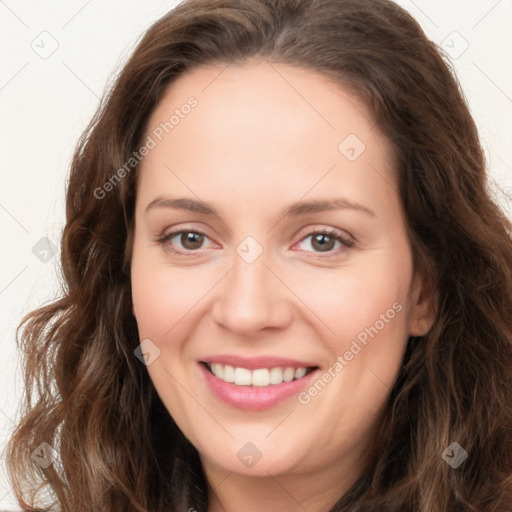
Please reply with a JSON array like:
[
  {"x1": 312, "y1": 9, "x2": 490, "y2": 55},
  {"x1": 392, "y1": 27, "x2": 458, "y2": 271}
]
[{"x1": 0, "y1": 0, "x2": 512, "y2": 510}]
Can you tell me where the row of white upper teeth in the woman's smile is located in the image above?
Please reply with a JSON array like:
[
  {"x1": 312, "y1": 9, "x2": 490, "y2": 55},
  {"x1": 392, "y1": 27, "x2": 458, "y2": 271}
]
[{"x1": 208, "y1": 363, "x2": 307, "y2": 387}]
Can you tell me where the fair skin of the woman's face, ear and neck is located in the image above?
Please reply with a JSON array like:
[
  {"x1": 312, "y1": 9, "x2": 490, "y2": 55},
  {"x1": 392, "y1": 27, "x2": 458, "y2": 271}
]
[{"x1": 131, "y1": 60, "x2": 433, "y2": 512}]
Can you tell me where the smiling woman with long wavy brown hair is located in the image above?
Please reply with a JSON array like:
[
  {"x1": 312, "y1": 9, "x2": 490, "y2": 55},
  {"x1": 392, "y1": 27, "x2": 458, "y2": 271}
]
[{"x1": 8, "y1": 0, "x2": 512, "y2": 512}]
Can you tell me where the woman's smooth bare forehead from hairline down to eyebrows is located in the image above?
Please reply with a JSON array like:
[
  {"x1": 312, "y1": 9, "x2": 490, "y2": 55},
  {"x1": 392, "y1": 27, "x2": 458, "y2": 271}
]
[{"x1": 140, "y1": 61, "x2": 400, "y2": 216}]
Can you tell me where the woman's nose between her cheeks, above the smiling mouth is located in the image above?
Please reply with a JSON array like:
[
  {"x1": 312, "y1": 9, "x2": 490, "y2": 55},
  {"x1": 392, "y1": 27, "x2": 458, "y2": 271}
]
[{"x1": 212, "y1": 247, "x2": 293, "y2": 336}]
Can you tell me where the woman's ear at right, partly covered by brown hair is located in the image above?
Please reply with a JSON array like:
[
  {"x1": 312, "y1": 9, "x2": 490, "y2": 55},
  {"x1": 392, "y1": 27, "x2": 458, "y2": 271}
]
[{"x1": 409, "y1": 272, "x2": 438, "y2": 336}]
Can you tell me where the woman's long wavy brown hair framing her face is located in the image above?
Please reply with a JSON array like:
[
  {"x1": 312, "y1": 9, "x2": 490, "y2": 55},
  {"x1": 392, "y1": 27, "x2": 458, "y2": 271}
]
[{"x1": 7, "y1": 0, "x2": 512, "y2": 512}]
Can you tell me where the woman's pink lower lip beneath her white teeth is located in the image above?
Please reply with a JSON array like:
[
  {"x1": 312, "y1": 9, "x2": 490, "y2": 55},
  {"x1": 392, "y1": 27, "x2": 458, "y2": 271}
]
[{"x1": 199, "y1": 363, "x2": 317, "y2": 411}]
